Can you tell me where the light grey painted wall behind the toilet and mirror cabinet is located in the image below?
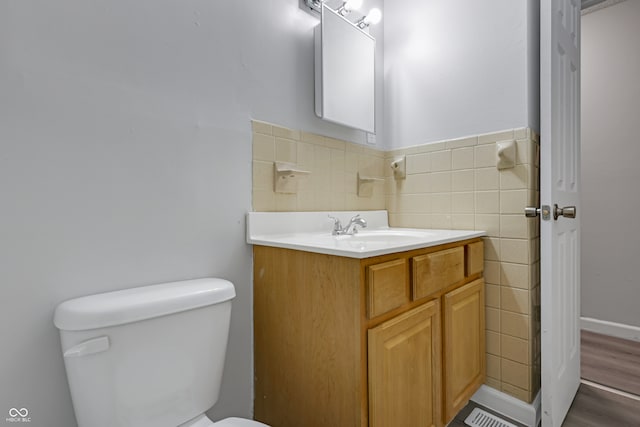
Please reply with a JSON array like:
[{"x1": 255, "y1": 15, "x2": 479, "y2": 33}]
[{"x1": 0, "y1": 0, "x2": 383, "y2": 427}]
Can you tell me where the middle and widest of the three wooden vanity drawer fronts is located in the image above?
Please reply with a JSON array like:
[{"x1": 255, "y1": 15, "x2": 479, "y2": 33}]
[{"x1": 411, "y1": 246, "x2": 464, "y2": 299}]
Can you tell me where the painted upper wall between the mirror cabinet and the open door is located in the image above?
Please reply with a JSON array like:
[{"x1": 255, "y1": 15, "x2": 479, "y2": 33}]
[{"x1": 384, "y1": 0, "x2": 539, "y2": 148}]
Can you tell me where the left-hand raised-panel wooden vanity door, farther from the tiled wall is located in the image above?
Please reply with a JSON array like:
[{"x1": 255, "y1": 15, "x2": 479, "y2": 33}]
[{"x1": 368, "y1": 300, "x2": 442, "y2": 427}]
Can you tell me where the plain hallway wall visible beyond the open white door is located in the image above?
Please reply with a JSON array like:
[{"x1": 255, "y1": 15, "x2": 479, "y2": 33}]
[{"x1": 581, "y1": 0, "x2": 640, "y2": 326}]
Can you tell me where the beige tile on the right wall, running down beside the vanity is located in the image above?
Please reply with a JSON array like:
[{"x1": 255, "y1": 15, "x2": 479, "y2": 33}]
[{"x1": 385, "y1": 129, "x2": 540, "y2": 402}]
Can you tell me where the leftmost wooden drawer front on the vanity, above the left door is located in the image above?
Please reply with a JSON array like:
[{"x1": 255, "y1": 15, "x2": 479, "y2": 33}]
[{"x1": 367, "y1": 258, "x2": 409, "y2": 319}]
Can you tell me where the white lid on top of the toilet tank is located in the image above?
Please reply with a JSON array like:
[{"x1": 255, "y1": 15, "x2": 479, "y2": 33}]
[{"x1": 53, "y1": 278, "x2": 236, "y2": 331}]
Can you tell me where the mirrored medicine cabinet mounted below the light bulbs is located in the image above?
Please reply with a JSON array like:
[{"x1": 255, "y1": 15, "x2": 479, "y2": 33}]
[{"x1": 315, "y1": 4, "x2": 376, "y2": 133}]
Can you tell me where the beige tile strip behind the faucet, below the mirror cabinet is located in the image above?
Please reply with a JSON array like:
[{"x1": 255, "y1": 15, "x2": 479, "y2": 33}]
[{"x1": 251, "y1": 121, "x2": 385, "y2": 212}]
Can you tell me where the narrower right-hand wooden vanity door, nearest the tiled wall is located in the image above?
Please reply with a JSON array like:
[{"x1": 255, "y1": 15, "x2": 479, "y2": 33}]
[{"x1": 443, "y1": 279, "x2": 485, "y2": 422}]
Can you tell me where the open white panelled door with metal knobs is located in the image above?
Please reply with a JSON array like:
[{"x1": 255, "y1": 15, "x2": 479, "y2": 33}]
[{"x1": 540, "y1": 0, "x2": 580, "y2": 427}]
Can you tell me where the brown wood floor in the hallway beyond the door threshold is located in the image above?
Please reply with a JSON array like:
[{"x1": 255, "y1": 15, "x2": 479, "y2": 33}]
[{"x1": 580, "y1": 331, "x2": 640, "y2": 396}]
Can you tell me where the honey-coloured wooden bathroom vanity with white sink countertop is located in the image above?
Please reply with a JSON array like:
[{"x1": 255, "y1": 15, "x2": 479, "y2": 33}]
[{"x1": 248, "y1": 212, "x2": 485, "y2": 427}]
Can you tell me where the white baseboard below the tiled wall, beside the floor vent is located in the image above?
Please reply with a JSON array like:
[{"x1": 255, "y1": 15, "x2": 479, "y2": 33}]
[{"x1": 471, "y1": 384, "x2": 541, "y2": 427}]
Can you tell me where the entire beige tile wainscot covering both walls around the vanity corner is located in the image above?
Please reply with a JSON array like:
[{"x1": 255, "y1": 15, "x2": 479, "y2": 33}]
[{"x1": 252, "y1": 121, "x2": 540, "y2": 402}]
